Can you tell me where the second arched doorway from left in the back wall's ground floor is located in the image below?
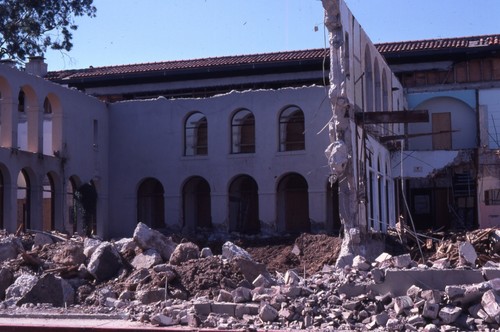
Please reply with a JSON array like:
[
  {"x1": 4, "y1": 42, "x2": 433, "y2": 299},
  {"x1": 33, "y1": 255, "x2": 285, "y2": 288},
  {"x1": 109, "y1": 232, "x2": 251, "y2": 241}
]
[{"x1": 182, "y1": 176, "x2": 212, "y2": 231}]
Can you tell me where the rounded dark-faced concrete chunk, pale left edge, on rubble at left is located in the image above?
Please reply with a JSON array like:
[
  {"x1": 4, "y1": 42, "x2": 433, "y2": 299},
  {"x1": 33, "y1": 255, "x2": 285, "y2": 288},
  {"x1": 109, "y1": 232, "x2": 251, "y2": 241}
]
[{"x1": 87, "y1": 242, "x2": 123, "y2": 281}]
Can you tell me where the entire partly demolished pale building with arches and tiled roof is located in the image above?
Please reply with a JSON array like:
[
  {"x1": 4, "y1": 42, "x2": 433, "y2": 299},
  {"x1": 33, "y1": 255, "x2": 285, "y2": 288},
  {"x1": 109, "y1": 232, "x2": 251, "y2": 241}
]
[{"x1": 0, "y1": 1, "x2": 498, "y2": 243}]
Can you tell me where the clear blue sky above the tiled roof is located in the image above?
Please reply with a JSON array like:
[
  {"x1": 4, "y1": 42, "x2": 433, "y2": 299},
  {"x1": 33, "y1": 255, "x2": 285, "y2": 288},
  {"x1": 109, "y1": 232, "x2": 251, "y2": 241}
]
[{"x1": 45, "y1": 0, "x2": 500, "y2": 70}]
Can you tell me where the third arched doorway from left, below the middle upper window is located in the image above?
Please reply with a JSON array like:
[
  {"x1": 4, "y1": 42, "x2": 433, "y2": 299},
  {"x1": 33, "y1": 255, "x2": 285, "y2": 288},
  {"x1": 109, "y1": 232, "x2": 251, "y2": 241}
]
[{"x1": 229, "y1": 175, "x2": 260, "y2": 234}]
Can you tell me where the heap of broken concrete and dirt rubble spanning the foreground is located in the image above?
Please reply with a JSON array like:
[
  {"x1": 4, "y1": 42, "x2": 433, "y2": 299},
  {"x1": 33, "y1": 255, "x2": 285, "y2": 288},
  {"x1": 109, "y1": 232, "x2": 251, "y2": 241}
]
[{"x1": 0, "y1": 224, "x2": 500, "y2": 331}]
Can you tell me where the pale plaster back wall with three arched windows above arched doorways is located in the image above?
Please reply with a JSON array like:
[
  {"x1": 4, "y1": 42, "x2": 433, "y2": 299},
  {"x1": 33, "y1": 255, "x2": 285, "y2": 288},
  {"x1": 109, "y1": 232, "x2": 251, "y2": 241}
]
[{"x1": 109, "y1": 87, "x2": 331, "y2": 236}]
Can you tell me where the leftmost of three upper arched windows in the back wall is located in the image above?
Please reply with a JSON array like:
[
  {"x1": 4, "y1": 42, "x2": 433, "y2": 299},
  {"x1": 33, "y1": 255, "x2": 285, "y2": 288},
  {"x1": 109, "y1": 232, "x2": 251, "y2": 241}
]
[{"x1": 184, "y1": 112, "x2": 208, "y2": 156}]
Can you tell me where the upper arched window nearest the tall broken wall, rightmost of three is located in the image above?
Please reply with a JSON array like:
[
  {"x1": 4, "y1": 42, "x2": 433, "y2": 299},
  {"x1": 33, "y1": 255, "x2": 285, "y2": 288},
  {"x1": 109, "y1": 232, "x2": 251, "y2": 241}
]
[{"x1": 279, "y1": 106, "x2": 305, "y2": 151}]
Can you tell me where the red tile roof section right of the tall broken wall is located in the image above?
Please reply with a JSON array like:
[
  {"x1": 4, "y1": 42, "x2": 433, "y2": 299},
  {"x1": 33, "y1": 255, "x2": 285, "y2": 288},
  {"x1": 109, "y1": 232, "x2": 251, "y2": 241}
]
[{"x1": 375, "y1": 35, "x2": 500, "y2": 55}]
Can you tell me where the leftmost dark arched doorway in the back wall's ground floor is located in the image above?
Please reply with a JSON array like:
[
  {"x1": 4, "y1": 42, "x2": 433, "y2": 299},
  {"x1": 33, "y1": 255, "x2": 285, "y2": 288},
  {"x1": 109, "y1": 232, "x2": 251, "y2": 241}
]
[{"x1": 137, "y1": 178, "x2": 165, "y2": 229}]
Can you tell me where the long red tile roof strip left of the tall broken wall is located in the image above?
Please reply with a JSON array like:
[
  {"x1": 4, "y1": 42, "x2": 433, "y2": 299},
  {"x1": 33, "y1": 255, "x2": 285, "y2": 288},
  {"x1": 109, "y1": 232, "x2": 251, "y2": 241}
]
[{"x1": 46, "y1": 49, "x2": 329, "y2": 80}]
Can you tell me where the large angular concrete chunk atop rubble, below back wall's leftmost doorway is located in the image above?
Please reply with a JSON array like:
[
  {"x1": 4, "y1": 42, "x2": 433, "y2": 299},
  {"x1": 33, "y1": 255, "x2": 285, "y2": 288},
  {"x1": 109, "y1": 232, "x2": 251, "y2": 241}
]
[{"x1": 133, "y1": 222, "x2": 177, "y2": 262}]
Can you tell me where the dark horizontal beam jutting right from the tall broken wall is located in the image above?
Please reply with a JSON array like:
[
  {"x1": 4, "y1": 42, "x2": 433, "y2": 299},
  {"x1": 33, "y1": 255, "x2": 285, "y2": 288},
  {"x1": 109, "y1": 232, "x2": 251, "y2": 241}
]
[{"x1": 354, "y1": 110, "x2": 429, "y2": 124}]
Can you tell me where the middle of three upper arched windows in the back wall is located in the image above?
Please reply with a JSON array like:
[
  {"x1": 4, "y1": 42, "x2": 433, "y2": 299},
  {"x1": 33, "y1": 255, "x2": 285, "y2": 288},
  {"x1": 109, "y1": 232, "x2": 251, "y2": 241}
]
[{"x1": 231, "y1": 109, "x2": 255, "y2": 153}]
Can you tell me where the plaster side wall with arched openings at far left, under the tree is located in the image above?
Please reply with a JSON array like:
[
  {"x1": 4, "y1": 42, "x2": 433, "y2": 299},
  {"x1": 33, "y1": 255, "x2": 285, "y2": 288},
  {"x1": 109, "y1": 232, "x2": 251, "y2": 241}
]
[{"x1": 0, "y1": 65, "x2": 108, "y2": 236}]
